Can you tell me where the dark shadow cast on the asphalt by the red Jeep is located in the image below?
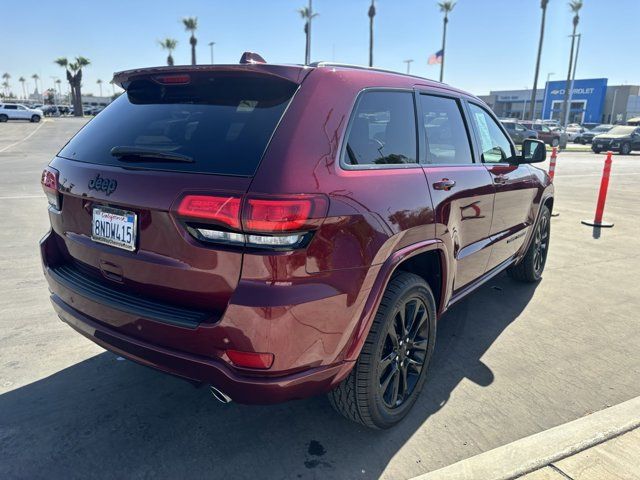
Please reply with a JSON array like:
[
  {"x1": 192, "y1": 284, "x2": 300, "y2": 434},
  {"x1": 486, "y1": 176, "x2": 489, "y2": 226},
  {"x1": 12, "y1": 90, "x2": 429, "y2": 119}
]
[{"x1": 0, "y1": 275, "x2": 536, "y2": 479}]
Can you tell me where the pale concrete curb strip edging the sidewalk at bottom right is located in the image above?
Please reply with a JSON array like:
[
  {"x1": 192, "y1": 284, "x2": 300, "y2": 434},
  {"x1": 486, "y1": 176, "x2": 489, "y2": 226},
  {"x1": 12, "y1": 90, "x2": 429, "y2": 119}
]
[{"x1": 412, "y1": 397, "x2": 640, "y2": 480}]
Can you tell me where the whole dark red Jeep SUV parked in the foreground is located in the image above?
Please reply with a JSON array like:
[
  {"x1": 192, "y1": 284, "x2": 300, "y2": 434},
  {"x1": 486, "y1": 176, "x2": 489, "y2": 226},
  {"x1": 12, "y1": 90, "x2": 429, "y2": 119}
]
[{"x1": 41, "y1": 56, "x2": 553, "y2": 428}]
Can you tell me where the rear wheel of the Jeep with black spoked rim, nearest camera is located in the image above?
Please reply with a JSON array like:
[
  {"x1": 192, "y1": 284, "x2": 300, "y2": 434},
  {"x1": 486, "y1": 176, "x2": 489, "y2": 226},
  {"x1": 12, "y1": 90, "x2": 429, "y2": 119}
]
[{"x1": 328, "y1": 272, "x2": 436, "y2": 429}]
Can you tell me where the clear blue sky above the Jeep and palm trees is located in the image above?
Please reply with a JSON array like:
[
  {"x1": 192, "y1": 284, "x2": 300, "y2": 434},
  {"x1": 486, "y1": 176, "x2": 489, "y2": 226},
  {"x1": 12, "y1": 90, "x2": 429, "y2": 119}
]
[{"x1": 0, "y1": 0, "x2": 640, "y2": 94}]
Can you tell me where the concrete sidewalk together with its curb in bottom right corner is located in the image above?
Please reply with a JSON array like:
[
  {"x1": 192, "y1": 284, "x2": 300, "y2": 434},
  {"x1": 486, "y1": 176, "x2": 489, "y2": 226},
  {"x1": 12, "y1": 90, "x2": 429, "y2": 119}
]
[{"x1": 413, "y1": 397, "x2": 640, "y2": 480}]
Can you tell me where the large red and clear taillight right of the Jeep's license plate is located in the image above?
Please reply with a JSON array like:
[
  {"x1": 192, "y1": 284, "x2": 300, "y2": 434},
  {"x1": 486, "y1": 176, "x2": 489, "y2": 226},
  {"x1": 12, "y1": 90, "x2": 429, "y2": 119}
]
[{"x1": 174, "y1": 195, "x2": 329, "y2": 249}]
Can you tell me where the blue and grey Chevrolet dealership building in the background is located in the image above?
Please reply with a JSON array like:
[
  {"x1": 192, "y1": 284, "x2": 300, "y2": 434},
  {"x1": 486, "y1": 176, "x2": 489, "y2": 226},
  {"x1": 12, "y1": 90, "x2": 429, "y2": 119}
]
[{"x1": 480, "y1": 78, "x2": 640, "y2": 123}]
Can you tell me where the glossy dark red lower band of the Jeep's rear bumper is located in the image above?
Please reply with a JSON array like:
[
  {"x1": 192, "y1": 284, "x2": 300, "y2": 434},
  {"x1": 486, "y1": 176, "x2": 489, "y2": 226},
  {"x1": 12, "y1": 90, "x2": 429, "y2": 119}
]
[{"x1": 51, "y1": 294, "x2": 353, "y2": 404}]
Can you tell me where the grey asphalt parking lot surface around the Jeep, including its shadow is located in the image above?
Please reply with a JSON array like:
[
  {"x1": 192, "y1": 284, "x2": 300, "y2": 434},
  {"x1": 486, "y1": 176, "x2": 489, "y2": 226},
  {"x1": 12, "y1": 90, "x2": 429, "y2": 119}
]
[{"x1": 0, "y1": 119, "x2": 640, "y2": 479}]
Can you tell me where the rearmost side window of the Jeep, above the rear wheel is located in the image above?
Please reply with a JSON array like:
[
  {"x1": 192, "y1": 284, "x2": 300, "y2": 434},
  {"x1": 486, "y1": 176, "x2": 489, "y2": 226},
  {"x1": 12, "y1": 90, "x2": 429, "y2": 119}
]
[{"x1": 343, "y1": 91, "x2": 418, "y2": 165}]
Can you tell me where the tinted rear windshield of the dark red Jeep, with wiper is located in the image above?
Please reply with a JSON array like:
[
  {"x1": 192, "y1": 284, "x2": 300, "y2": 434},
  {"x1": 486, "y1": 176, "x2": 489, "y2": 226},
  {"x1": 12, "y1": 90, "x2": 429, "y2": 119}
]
[{"x1": 58, "y1": 73, "x2": 297, "y2": 176}]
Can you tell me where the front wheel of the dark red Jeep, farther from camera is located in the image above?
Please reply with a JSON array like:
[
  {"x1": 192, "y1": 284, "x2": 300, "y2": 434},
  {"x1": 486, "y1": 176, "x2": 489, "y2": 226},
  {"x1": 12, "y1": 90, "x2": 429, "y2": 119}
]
[{"x1": 507, "y1": 205, "x2": 551, "y2": 283}]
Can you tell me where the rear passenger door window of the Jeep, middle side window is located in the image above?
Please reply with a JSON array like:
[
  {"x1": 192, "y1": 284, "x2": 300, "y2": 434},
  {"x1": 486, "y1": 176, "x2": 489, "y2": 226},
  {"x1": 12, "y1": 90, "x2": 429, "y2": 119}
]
[{"x1": 420, "y1": 94, "x2": 473, "y2": 164}]
